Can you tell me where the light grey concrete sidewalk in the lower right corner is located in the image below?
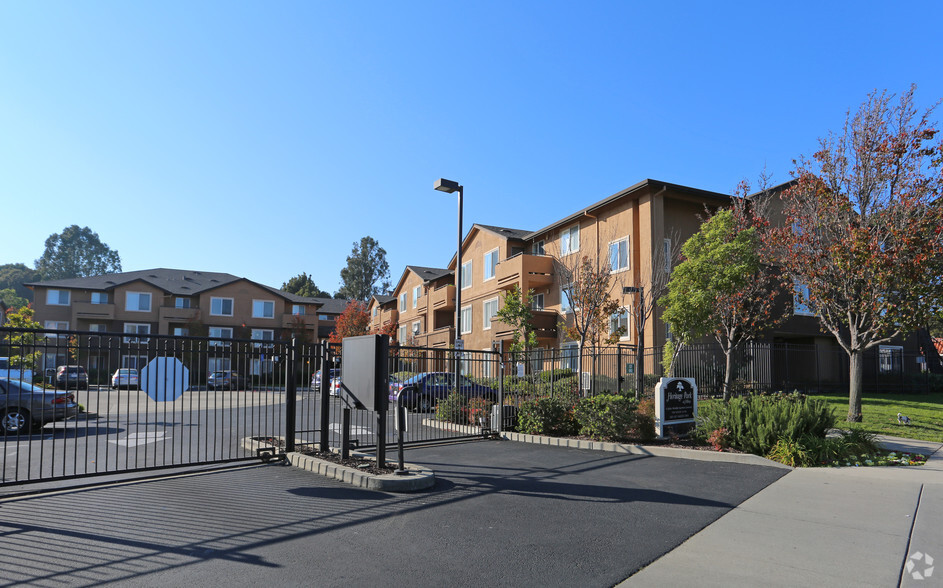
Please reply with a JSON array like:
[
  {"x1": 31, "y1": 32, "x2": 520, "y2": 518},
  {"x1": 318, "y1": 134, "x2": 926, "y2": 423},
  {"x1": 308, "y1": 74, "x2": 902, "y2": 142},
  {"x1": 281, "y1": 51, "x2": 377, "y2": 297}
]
[{"x1": 620, "y1": 437, "x2": 943, "y2": 587}]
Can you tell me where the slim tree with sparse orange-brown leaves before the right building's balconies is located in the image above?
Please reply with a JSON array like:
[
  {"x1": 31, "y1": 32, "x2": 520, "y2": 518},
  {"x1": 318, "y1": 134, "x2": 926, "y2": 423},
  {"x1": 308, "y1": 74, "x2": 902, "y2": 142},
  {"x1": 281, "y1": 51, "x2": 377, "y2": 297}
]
[{"x1": 554, "y1": 255, "x2": 619, "y2": 386}]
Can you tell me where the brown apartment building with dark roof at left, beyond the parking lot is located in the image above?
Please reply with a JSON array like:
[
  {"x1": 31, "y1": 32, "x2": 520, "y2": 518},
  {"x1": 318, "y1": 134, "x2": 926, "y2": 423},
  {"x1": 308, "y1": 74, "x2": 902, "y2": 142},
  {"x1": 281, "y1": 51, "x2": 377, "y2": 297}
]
[{"x1": 26, "y1": 268, "x2": 338, "y2": 369}]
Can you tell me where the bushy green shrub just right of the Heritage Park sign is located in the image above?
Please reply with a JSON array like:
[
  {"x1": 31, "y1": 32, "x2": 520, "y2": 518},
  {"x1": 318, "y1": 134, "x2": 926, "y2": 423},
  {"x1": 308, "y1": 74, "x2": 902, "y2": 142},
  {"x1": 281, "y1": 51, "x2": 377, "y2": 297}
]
[{"x1": 696, "y1": 394, "x2": 835, "y2": 455}]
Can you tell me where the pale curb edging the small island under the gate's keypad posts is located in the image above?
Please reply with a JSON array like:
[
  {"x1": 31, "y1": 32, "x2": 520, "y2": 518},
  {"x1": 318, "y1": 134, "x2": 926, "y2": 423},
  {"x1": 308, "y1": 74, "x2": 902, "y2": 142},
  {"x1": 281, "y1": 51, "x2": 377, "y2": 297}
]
[{"x1": 242, "y1": 437, "x2": 435, "y2": 492}]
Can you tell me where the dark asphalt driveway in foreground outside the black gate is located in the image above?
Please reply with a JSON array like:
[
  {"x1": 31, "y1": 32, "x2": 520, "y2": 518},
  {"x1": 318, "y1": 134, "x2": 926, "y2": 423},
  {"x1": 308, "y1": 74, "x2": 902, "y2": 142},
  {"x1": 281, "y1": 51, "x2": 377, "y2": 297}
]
[{"x1": 0, "y1": 441, "x2": 786, "y2": 586}]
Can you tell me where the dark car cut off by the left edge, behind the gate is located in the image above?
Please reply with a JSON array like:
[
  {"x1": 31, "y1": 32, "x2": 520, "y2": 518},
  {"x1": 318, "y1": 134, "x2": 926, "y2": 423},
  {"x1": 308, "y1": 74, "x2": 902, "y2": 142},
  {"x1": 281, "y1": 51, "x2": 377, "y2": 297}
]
[{"x1": 0, "y1": 378, "x2": 79, "y2": 435}]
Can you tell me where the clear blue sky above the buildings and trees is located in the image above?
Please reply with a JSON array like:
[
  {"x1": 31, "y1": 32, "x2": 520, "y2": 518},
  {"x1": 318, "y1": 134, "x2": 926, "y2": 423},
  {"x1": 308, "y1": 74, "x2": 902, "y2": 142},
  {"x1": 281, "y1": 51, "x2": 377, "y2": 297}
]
[{"x1": 0, "y1": 0, "x2": 943, "y2": 292}]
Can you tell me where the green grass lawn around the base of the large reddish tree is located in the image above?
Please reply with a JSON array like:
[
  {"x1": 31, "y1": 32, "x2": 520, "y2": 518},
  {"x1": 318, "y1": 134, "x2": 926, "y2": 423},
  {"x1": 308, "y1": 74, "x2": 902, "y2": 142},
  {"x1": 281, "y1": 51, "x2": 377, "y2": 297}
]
[{"x1": 815, "y1": 394, "x2": 943, "y2": 443}]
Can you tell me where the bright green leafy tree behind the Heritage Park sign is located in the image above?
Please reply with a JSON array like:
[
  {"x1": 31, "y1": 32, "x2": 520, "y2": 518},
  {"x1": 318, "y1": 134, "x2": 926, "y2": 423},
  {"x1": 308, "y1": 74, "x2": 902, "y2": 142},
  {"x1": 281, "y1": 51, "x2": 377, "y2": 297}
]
[{"x1": 662, "y1": 209, "x2": 780, "y2": 402}]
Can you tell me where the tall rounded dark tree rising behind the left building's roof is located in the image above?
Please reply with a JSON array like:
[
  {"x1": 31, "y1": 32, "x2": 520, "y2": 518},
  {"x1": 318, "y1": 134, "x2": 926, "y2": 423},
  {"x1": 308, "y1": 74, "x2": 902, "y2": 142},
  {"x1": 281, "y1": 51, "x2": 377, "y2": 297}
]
[{"x1": 36, "y1": 225, "x2": 121, "y2": 280}]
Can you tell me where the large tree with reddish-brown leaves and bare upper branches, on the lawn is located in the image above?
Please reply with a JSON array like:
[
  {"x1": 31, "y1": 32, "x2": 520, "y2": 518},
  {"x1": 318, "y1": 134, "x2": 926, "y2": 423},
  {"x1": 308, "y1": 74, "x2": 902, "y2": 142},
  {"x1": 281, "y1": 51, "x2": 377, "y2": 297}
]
[{"x1": 773, "y1": 86, "x2": 943, "y2": 422}]
